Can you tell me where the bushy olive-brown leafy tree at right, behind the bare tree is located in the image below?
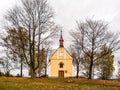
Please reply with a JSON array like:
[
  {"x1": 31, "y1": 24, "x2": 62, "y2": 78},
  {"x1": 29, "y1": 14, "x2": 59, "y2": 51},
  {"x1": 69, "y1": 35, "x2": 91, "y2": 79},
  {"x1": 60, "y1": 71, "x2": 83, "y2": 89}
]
[{"x1": 95, "y1": 45, "x2": 114, "y2": 79}]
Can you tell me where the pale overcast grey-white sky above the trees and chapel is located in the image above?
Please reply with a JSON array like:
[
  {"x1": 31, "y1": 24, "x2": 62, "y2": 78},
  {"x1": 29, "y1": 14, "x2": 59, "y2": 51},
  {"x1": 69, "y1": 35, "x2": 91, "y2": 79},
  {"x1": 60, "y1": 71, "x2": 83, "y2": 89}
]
[{"x1": 0, "y1": 0, "x2": 120, "y2": 76}]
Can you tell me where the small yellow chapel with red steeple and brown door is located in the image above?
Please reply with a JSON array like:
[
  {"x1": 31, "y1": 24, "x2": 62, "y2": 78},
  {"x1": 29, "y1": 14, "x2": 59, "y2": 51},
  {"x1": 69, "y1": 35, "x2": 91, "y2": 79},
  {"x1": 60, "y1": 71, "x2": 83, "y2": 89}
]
[{"x1": 50, "y1": 31, "x2": 73, "y2": 78}]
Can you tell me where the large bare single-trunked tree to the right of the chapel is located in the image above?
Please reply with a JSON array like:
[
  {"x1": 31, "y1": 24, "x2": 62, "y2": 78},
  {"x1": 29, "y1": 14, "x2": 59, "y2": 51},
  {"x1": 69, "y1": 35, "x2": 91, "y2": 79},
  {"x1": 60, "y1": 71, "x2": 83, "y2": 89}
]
[{"x1": 73, "y1": 19, "x2": 120, "y2": 79}]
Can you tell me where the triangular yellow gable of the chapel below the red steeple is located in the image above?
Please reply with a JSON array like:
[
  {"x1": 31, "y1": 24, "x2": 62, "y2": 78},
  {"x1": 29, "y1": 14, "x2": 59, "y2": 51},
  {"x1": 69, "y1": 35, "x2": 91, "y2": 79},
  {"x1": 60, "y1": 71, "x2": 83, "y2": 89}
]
[{"x1": 50, "y1": 47, "x2": 73, "y2": 60}]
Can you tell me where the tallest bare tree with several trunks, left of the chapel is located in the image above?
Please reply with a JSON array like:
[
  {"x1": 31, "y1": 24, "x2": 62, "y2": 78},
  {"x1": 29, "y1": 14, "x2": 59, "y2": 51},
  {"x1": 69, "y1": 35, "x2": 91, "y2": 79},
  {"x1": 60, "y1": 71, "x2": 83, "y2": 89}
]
[{"x1": 5, "y1": 0, "x2": 58, "y2": 77}]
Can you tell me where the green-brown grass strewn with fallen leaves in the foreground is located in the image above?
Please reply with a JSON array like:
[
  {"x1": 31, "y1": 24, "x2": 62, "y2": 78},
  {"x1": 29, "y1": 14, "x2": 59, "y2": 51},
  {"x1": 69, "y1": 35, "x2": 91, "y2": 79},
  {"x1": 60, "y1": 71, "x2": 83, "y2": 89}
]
[{"x1": 0, "y1": 77, "x2": 120, "y2": 90}]
